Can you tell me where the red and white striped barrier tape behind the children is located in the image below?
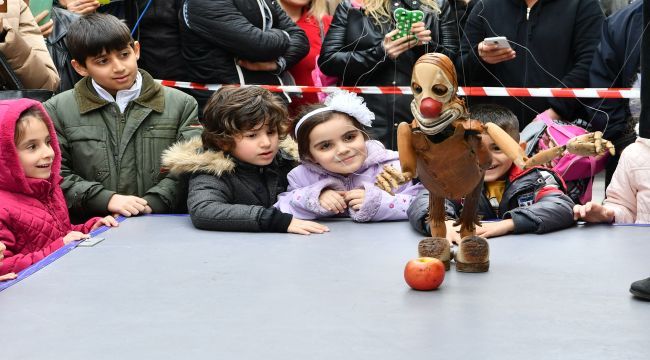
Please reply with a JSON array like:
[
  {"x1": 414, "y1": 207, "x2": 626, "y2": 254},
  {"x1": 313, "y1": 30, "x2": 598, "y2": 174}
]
[{"x1": 156, "y1": 80, "x2": 641, "y2": 99}]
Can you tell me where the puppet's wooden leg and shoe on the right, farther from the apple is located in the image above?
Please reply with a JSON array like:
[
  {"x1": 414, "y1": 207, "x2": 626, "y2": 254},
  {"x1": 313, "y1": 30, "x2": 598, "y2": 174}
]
[{"x1": 456, "y1": 183, "x2": 490, "y2": 272}]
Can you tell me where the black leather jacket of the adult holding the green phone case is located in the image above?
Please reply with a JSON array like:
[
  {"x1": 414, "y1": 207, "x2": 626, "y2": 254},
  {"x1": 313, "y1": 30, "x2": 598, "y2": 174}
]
[{"x1": 318, "y1": 0, "x2": 459, "y2": 149}]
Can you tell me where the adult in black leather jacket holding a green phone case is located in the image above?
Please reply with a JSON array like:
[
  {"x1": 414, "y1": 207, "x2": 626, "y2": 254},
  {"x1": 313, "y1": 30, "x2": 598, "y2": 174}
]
[{"x1": 318, "y1": 0, "x2": 458, "y2": 149}]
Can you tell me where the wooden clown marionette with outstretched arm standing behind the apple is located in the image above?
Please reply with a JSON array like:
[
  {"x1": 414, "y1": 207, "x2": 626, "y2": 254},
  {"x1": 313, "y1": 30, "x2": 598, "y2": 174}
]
[{"x1": 376, "y1": 53, "x2": 614, "y2": 272}]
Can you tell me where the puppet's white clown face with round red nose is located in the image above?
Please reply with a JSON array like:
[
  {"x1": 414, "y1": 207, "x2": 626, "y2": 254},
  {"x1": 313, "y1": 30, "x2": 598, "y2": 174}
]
[{"x1": 411, "y1": 63, "x2": 456, "y2": 132}]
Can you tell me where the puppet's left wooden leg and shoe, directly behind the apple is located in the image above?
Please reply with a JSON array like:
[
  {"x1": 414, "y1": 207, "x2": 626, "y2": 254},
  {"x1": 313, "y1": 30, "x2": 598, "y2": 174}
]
[{"x1": 418, "y1": 194, "x2": 451, "y2": 270}]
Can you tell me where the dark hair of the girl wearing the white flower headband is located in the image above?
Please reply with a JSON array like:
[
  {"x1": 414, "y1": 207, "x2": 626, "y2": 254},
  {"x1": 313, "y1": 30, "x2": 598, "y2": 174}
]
[{"x1": 289, "y1": 104, "x2": 369, "y2": 160}]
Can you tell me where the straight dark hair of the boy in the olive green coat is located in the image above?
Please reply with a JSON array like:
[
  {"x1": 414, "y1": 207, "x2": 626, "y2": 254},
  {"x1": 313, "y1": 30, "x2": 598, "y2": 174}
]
[{"x1": 66, "y1": 13, "x2": 134, "y2": 66}]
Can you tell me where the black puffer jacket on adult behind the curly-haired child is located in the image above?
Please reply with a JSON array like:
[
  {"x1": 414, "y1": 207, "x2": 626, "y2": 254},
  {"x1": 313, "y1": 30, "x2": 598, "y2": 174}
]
[{"x1": 180, "y1": 0, "x2": 309, "y2": 111}]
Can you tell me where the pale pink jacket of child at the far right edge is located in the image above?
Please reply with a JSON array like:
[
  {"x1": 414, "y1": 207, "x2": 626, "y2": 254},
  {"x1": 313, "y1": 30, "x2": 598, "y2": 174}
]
[{"x1": 604, "y1": 138, "x2": 650, "y2": 224}]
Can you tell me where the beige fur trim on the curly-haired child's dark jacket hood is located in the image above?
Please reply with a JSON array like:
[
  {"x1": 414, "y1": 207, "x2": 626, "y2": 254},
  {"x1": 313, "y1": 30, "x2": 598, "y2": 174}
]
[{"x1": 162, "y1": 136, "x2": 298, "y2": 176}]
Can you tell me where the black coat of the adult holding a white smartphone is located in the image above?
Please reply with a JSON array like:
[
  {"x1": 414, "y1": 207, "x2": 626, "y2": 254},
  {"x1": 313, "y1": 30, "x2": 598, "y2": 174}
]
[{"x1": 456, "y1": 0, "x2": 605, "y2": 128}]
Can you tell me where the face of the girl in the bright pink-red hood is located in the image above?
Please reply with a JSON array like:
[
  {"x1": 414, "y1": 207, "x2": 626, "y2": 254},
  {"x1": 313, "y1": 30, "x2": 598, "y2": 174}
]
[{"x1": 16, "y1": 116, "x2": 54, "y2": 179}]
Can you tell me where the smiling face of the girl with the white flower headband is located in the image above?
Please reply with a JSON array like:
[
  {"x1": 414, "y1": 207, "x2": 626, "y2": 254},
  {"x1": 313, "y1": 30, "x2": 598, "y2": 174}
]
[{"x1": 309, "y1": 114, "x2": 368, "y2": 175}]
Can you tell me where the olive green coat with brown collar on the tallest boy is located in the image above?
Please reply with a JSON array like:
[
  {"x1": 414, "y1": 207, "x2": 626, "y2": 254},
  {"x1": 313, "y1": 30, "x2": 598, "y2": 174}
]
[{"x1": 44, "y1": 70, "x2": 201, "y2": 217}]
